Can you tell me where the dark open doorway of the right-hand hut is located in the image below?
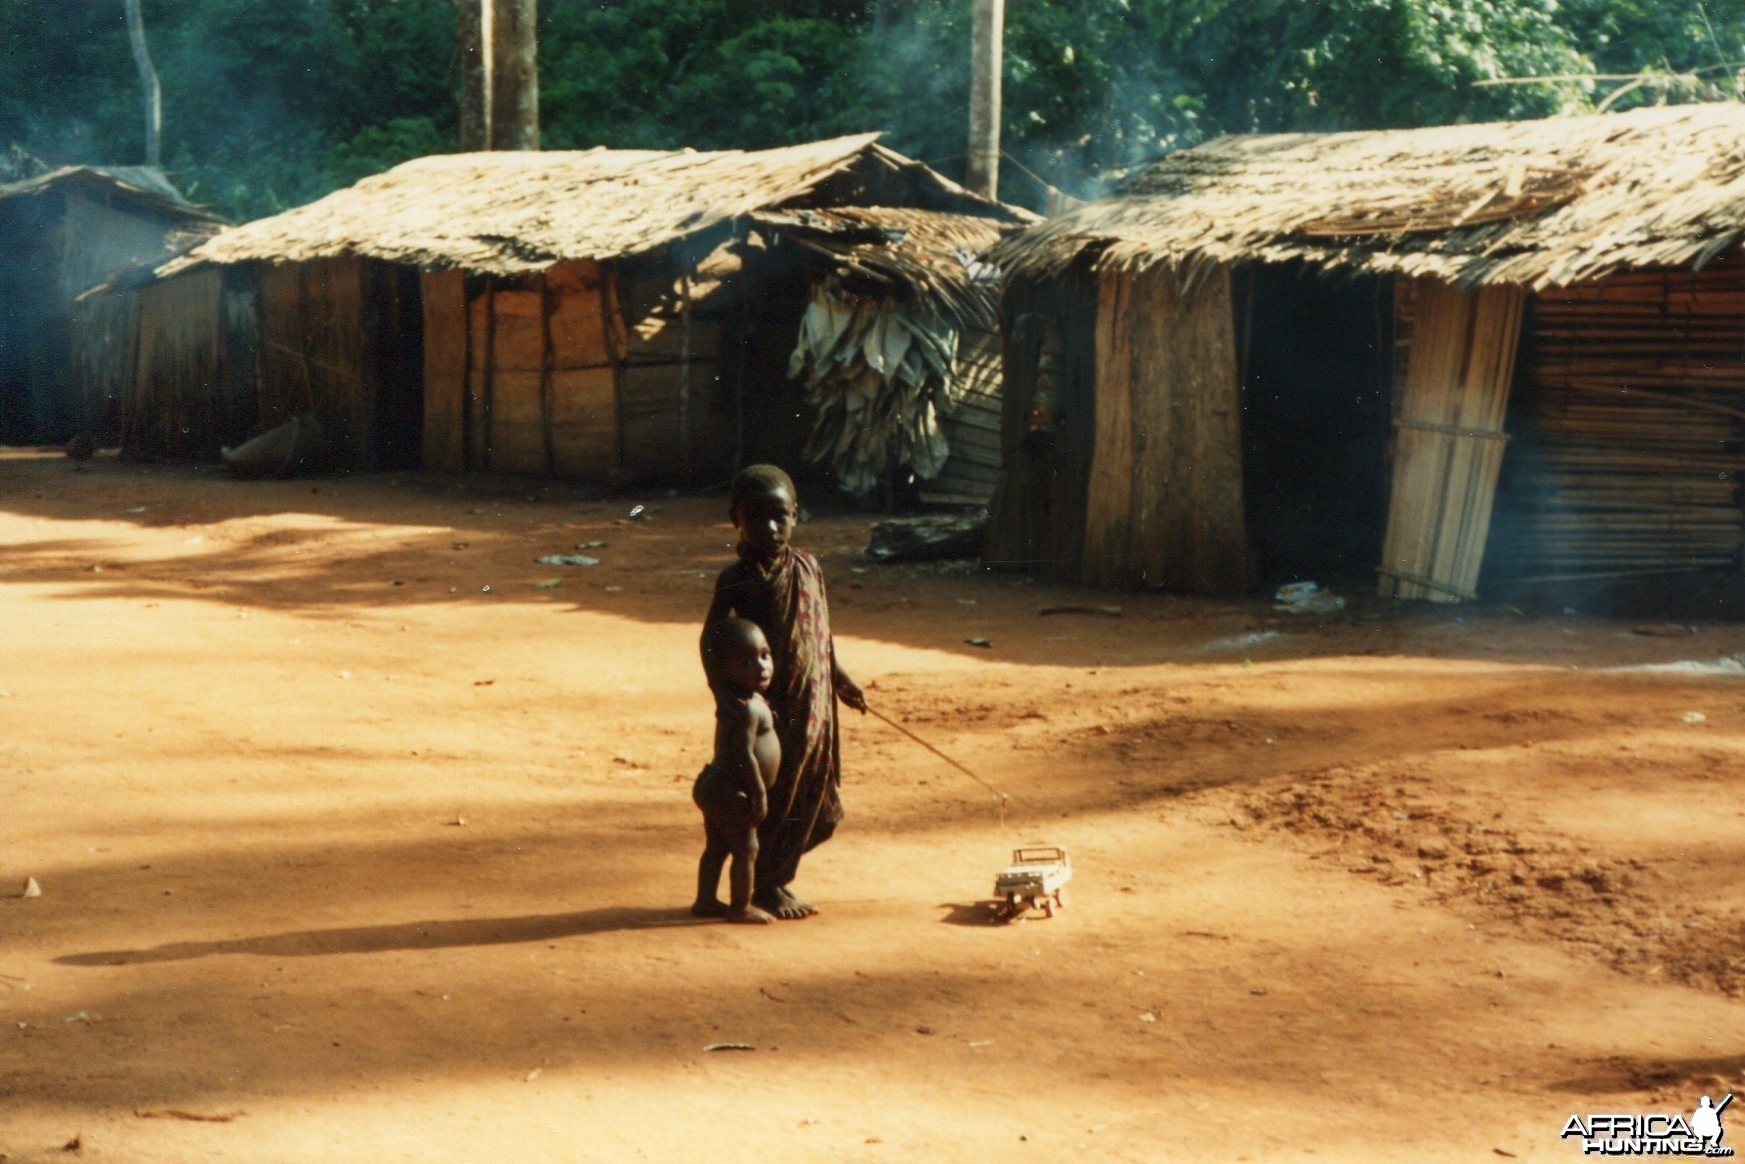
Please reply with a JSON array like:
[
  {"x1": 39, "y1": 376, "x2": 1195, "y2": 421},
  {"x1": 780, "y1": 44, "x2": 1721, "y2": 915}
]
[{"x1": 1235, "y1": 264, "x2": 1393, "y2": 588}]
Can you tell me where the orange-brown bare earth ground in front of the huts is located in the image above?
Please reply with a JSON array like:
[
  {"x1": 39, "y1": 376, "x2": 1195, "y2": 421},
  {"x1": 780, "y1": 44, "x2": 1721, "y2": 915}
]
[{"x1": 0, "y1": 452, "x2": 1745, "y2": 1162}]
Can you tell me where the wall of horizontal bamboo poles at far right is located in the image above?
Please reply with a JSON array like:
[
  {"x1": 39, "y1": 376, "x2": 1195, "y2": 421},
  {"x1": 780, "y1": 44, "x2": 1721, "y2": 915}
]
[{"x1": 1495, "y1": 258, "x2": 1745, "y2": 581}]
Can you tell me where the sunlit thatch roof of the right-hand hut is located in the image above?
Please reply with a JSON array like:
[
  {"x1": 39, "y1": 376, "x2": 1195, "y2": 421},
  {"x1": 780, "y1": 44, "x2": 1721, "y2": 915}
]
[{"x1": 995, "y1": 103, "x2": 1745, "y2": 288}]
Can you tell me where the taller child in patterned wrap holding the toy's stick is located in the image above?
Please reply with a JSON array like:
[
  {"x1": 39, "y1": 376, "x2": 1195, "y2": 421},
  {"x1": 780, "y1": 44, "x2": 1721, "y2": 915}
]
[{"x1": 703, "y1": 464, "x2": 867, "y2": 918}]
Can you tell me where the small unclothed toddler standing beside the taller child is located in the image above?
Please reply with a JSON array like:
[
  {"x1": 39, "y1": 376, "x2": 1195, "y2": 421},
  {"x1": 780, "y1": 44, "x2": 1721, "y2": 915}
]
[{"x1": 691, "y1": 618, "x2": 782, "y2": 923}]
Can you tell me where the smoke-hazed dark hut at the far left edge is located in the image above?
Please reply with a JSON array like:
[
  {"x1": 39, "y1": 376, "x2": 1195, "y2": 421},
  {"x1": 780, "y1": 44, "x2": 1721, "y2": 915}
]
[{"x1": 0, "y1": 166, "x2": 220, "y2": 443}]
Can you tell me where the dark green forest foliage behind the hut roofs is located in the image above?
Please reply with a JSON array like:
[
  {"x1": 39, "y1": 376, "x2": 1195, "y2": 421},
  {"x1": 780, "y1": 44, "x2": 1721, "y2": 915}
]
[{"x1": 0, "y1": 0, "x2": 1745, "y2": 218}]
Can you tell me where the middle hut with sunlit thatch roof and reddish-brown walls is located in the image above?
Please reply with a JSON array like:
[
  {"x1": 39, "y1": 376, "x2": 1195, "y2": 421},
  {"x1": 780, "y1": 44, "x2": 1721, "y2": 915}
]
[{"x1": 146, "y1": 134, "x2": 1026, "y2": 482}]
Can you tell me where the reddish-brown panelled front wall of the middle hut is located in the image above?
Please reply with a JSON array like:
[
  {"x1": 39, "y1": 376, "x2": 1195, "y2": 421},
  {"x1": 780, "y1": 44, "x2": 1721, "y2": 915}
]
[{"x1": 422, "y1": 254, "x2": 735, "y2": 483}]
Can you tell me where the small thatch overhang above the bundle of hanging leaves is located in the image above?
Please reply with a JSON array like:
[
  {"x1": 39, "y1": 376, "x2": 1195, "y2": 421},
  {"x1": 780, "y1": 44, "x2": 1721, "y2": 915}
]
[{"x1": 752, "y1": 206, "x2": 1038, "y2": 332}]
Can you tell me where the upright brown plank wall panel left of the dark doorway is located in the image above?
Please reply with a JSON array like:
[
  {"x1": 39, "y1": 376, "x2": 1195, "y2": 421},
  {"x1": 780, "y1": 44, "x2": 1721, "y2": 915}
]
[{"x1": 1082, "y1": 267, "x2": 1248, "y2": 593}]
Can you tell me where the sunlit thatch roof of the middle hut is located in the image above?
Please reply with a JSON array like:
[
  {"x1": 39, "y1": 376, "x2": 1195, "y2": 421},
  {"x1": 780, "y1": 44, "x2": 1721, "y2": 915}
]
[{"x1": 164, "y1": 134, "x2": 1014, "y2": 276}]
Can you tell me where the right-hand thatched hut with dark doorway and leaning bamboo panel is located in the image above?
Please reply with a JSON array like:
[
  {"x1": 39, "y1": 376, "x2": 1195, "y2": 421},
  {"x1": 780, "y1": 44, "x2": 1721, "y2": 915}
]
[{"x1": 991, "y1": 105, "x2": 1745, "y2": 600}]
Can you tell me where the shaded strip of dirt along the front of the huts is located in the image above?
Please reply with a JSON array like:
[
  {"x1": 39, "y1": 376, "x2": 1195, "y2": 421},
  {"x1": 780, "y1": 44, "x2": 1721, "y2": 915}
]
[{"x1": 0, "y1": 455, "x2": 1738, "y2": 667}]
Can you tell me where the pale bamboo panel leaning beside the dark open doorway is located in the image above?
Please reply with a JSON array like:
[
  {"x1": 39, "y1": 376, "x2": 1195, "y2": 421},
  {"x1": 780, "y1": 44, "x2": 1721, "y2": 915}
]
[{"x1": 1377, "y1": 279, "x2": 1525, "y2": 602}]
